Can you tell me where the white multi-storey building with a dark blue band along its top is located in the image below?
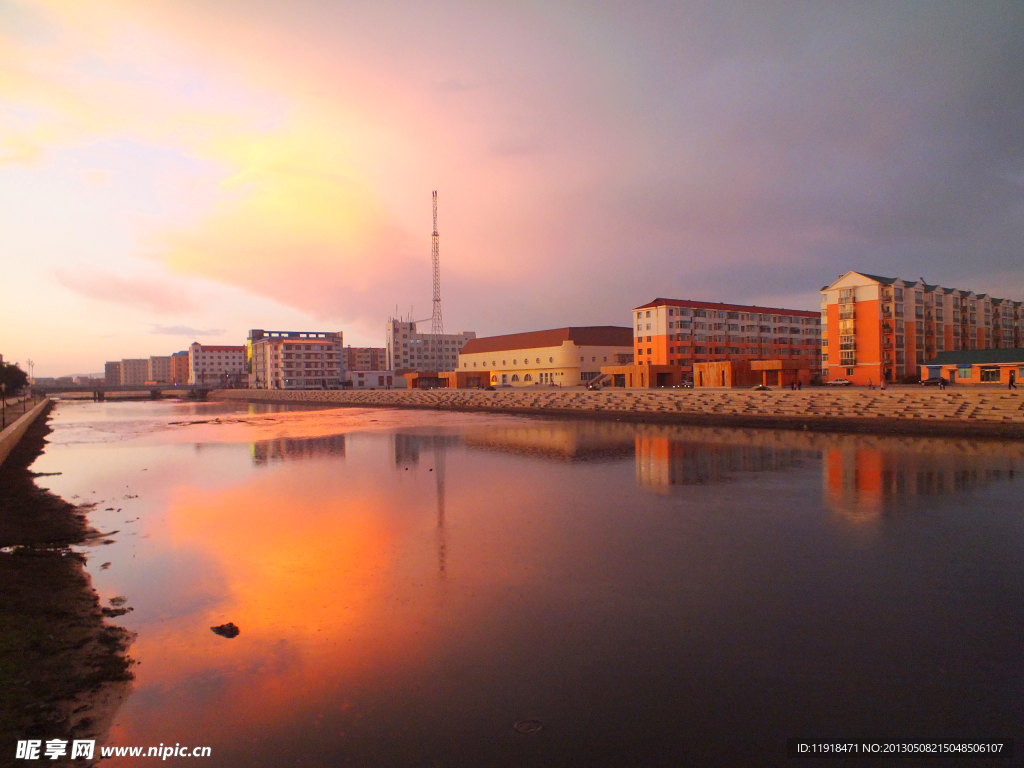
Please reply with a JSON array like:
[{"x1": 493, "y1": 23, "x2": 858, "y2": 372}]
[{"x1": 248, "y1": 329, "x2": 345, "y2": 389}]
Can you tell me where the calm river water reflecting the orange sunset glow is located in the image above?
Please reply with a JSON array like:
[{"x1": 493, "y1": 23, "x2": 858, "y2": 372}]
[{"x1": 34, "y1": 402, "x2": 1024, "y2": 768}]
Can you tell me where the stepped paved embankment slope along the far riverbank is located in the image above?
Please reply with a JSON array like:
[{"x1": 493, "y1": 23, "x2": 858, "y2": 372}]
[{"x1": 211, "y1": 387, "x2": 1024, "y2": 439}]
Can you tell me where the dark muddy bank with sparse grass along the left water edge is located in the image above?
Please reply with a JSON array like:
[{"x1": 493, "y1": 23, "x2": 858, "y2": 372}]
[{"x1": 0, "y1": 405, "x2": 132, "y2": 766}]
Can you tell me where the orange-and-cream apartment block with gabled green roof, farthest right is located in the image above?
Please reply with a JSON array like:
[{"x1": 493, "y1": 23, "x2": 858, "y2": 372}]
[{"x1": 821, "y1": 272, "x2": 1021, "y2": 384}]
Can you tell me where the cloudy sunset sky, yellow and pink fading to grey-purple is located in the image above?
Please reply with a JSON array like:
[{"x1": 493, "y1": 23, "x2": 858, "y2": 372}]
[{"x1": 0, "y1": 0, "x2": 1024, "y2": 376}]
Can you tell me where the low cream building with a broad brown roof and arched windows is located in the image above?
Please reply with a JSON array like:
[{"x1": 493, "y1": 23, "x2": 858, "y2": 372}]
[{"x1": 458, "y1": 326, "x2": 633, "y2": 387}]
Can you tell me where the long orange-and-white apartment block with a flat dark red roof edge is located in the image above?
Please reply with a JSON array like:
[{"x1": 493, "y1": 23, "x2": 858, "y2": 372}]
[{"x1": 633, "y1": 299, "x2": 821, "y2": 379}]
